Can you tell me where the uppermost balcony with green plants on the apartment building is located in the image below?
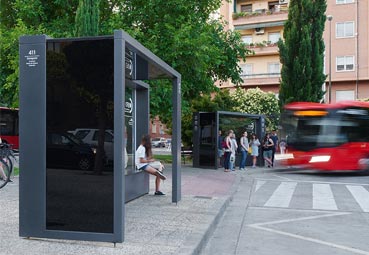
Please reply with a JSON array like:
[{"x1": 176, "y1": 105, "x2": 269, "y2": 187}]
[{"x1": 232, "y1": 10, "x2": 288, "y2": 27}]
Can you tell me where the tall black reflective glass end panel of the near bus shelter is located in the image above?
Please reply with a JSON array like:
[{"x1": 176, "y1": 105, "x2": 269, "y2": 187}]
[{"x1": 46, "y1": 39, "x2": 114, "y2": 233}]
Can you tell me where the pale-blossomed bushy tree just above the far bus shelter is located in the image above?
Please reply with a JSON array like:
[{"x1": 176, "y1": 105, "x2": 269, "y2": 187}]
[{"x1": 231, "y1": 88, "x2": 280, "y2": 130}]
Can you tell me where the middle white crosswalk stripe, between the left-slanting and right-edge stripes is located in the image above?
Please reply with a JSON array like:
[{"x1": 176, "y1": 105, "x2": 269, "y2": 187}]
[{"x1": 313, "y1": 183, "x2": 337, "y2": 210}]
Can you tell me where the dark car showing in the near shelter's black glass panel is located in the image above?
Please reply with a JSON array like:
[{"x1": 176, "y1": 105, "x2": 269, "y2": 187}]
[{"x1": 46, "y1": 132, "x2": 95, "y2": 170}]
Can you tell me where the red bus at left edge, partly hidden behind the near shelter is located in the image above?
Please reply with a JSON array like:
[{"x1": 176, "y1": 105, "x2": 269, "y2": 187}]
[{"x1": 0, "y1": 107, "x2": 19, "y2": 150}]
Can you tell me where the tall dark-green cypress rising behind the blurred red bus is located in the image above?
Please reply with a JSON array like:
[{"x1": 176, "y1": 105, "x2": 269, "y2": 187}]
[{"x1": 278, "y1": 0, "x2": 327, "y2": 107}]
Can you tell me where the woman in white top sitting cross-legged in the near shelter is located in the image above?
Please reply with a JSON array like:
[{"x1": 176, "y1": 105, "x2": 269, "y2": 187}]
[{"x1": 135, "y1": 135, "x2": 166, "y2": 195}]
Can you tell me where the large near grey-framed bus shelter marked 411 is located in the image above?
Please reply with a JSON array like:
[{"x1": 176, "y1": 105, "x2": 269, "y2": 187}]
[{"x1": 19, "y1": 30, "x2": 181, "y2": 243}]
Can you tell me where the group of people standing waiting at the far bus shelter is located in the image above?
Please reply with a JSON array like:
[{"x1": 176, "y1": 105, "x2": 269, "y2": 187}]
[{"x1": 218, "y1": 130, "x2": 278, "y2": 172}]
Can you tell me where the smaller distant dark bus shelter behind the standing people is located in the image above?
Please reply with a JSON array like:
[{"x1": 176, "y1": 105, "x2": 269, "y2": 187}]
[{"x1": 193, "y1": 111, "x2": 265, "y2": 169}]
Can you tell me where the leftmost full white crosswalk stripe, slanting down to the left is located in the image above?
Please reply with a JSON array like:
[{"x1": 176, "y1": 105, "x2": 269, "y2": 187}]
[{"x1": 264, "y1": 182, "x2": 297, "y2": 207}]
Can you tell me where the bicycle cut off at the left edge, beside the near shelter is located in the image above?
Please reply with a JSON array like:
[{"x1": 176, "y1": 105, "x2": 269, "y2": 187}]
[{"x1": 0, "y1": 143, "x2": 17, "y2": 189}]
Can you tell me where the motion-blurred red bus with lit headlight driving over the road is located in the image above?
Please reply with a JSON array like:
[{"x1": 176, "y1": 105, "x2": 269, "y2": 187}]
[{"x1": 281, "y1": 101, "x2": 369, "y2": 171}]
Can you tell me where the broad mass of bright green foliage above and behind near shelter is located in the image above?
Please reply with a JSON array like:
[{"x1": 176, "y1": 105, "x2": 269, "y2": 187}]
[{"x1": 0, "y1": 0, "x2": 249, "y2": 123}]
